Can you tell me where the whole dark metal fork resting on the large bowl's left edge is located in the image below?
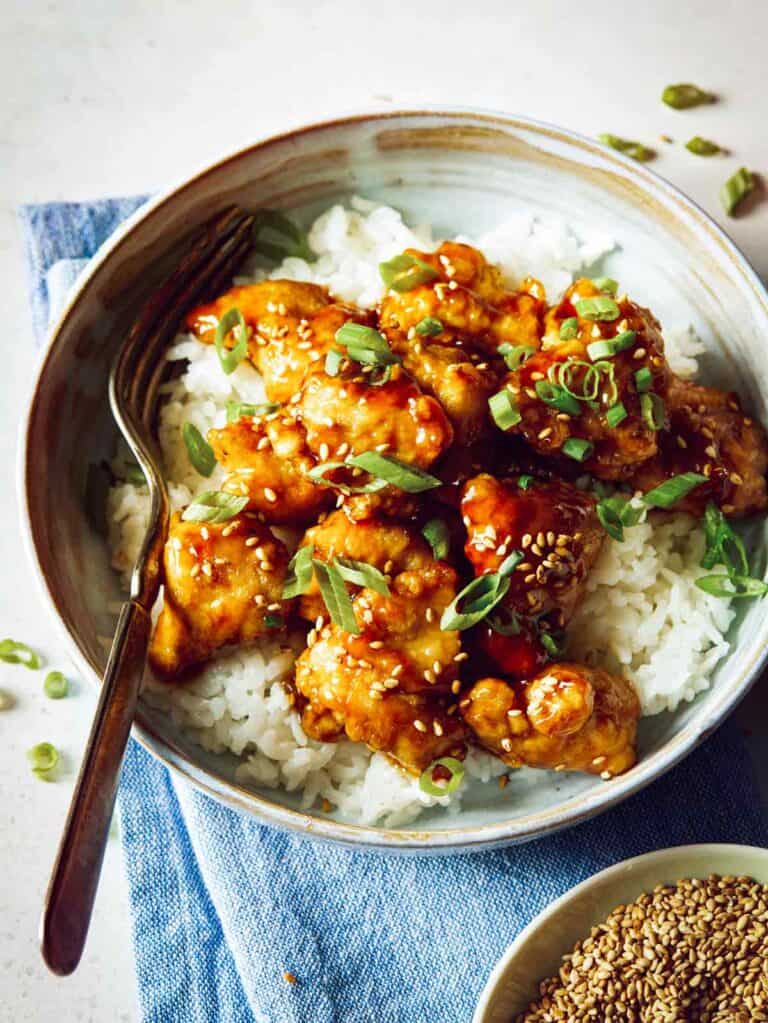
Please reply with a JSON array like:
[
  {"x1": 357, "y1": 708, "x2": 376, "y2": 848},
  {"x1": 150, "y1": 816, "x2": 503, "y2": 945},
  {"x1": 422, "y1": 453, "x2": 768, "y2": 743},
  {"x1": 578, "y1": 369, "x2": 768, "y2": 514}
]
[{"x1": 41, "y1": 207, "x2": 254, "y2": 975}]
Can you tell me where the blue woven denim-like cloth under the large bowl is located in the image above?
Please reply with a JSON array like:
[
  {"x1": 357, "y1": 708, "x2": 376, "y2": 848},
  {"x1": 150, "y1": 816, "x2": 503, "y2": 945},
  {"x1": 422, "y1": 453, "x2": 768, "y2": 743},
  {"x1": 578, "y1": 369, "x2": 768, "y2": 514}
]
[{"x1": 21, "y1": 199, "x2": 768, "y2": 1023}]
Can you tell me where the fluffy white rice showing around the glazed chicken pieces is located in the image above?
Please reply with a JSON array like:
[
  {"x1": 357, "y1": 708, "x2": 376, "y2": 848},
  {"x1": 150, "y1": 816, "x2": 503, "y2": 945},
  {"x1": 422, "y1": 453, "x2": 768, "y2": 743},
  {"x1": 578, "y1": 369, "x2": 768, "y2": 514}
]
[{"x1": 107, "y1": 199, "x2": 733, "y2": 827}]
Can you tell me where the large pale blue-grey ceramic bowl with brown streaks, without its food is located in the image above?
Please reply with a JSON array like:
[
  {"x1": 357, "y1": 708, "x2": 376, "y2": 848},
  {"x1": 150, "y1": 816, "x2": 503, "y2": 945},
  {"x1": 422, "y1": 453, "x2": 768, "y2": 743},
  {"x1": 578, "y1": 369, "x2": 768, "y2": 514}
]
[{"x1": 21, "y1": 110, "x2": 768, "y2": 851}]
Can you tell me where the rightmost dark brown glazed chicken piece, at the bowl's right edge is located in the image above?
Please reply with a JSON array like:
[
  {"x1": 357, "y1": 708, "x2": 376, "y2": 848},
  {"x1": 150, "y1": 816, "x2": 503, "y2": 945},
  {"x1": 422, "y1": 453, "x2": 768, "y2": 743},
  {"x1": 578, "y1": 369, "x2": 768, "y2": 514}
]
[{"x1": 632, "y1": 377, "x2": 768, "y2": 518}]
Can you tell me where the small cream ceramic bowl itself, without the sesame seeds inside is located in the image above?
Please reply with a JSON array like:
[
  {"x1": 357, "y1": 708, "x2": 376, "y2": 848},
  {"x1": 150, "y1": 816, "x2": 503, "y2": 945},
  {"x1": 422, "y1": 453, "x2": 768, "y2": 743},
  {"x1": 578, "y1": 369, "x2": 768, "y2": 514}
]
[{"x1": 472, "y1": 845, "x2": 768, "y2": 1023}]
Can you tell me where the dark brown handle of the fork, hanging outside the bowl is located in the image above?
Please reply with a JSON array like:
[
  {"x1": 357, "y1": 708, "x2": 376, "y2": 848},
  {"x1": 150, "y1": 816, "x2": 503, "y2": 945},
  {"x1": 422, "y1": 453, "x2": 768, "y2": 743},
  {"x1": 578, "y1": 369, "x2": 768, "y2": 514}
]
[{"x1": 41, "y1": 601, "x2": 151, "y2": 976}]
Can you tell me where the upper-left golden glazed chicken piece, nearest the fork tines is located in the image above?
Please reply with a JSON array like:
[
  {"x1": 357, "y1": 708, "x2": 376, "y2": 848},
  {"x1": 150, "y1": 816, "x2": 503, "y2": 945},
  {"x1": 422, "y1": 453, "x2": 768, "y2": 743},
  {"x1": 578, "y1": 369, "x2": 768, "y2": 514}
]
[{"x1": 187, "y1": 280, "x2": 367, "y2": 404}]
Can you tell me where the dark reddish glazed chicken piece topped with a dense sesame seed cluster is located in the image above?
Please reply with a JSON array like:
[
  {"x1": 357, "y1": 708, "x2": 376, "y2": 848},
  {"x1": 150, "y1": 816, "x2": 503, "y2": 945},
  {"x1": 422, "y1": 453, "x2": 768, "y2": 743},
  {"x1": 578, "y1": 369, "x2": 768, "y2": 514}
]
[{"x1": 461, "y1": 473, "x2": 604, "y2": 626}]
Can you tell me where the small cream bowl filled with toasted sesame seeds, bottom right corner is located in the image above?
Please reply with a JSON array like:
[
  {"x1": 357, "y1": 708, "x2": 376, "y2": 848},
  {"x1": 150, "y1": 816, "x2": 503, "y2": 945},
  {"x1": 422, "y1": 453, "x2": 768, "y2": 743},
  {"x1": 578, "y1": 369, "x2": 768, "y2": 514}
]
[{"x1": 472, "y1": 845, "x2": 768, "y2": 1023}]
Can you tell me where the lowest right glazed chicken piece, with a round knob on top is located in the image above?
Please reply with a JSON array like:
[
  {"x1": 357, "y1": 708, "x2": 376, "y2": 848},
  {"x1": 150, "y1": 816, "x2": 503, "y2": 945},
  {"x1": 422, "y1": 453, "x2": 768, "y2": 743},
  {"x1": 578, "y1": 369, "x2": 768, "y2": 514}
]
[{"x1": 459, "y1": 663, "x2": 640, "y2": 779}]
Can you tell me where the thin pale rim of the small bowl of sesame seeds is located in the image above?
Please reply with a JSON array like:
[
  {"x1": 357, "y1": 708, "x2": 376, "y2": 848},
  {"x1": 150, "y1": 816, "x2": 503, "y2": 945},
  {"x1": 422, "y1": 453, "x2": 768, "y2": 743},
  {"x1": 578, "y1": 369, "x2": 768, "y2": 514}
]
[{"x1": 471, "y1": 842, "x2": 768, "y2": 1023}]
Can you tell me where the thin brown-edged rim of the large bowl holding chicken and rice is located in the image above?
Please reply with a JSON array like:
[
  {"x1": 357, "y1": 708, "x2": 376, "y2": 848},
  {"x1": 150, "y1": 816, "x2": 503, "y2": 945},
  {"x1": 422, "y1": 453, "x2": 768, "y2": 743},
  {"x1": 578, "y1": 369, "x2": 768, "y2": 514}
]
[{"x1": 17, "y1": 104, "x2": 768, "y2": 852}]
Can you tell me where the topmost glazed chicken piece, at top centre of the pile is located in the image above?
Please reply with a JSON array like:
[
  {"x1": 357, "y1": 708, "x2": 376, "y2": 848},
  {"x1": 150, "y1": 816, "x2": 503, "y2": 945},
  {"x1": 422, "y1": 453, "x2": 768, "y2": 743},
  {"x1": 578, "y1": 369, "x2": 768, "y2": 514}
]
[{"x1": 379, "y1": 241, "x2": 544, "y2": 444}]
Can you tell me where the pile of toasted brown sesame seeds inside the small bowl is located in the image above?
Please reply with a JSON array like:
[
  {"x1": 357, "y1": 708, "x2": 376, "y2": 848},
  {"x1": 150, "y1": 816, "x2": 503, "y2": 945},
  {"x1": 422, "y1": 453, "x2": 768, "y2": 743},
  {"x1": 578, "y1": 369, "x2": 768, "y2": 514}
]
[{"x1": 515, "y1": 875, "x2": 768, "y2": 1023}]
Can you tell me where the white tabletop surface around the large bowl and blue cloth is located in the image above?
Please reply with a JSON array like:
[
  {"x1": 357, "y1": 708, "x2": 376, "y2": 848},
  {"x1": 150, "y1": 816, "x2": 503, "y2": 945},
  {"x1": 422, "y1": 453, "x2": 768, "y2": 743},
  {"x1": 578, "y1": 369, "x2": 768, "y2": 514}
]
[{"x1": 0, "y1": 0, "x2": 768, "y2": 1023}]
